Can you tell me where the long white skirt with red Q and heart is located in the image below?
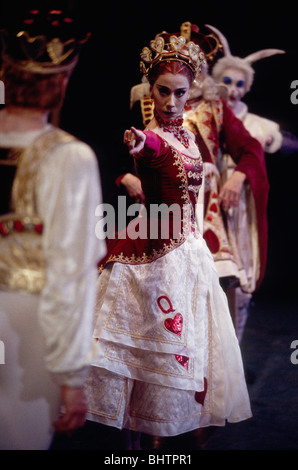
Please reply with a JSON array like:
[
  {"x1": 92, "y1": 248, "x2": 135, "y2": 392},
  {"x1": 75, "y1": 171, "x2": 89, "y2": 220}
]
[{"x1": 87, "y1": 235, "x2": 251, "y2": 436}]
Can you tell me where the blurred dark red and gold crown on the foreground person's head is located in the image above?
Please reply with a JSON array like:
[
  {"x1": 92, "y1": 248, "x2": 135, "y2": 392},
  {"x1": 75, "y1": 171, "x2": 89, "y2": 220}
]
[{"x1": 1, "y1": 10, "x2": 90, "y2": 74}]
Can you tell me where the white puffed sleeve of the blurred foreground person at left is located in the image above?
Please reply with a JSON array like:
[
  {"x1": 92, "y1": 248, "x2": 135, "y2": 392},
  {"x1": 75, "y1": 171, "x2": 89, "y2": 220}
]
[{"x1": 36, "y1": 142, "x2": 106, "y2": 386}]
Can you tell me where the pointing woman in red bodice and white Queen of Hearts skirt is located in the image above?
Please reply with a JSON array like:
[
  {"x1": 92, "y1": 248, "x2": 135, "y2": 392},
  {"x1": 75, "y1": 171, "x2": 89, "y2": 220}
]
[{"x1": 88, "y1": 28, "x2": 251, "y2": 444}]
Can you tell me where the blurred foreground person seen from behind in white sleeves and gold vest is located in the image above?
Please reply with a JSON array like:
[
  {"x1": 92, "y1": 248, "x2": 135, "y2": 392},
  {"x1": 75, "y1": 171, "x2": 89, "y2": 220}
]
[{"x1": 0, "y1": 10, "x2": 106, "y2": 450}]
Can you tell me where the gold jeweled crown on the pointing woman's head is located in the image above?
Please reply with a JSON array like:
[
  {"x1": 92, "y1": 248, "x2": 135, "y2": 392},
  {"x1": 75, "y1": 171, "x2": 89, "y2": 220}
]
[{"x1": 140, "y1": 31, "x2": 205, "y2": 76}]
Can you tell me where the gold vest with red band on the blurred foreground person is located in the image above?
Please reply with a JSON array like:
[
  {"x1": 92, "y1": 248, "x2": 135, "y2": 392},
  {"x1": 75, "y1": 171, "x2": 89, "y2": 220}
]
[{"x1": 0, "y1": 128, "x2": 75, "y2": 293}]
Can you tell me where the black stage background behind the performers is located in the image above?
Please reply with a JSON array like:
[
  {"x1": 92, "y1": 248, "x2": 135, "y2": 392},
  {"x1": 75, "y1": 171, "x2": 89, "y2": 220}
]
[{"x1": 0, "y1": 0, "x2": 298, "y2": 302}]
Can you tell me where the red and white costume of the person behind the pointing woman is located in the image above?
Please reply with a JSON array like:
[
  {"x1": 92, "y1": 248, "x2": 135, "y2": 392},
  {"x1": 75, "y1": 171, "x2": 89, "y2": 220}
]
[{"x1": 185, "y1": 99, "x2": 269, "y2": 340}]
